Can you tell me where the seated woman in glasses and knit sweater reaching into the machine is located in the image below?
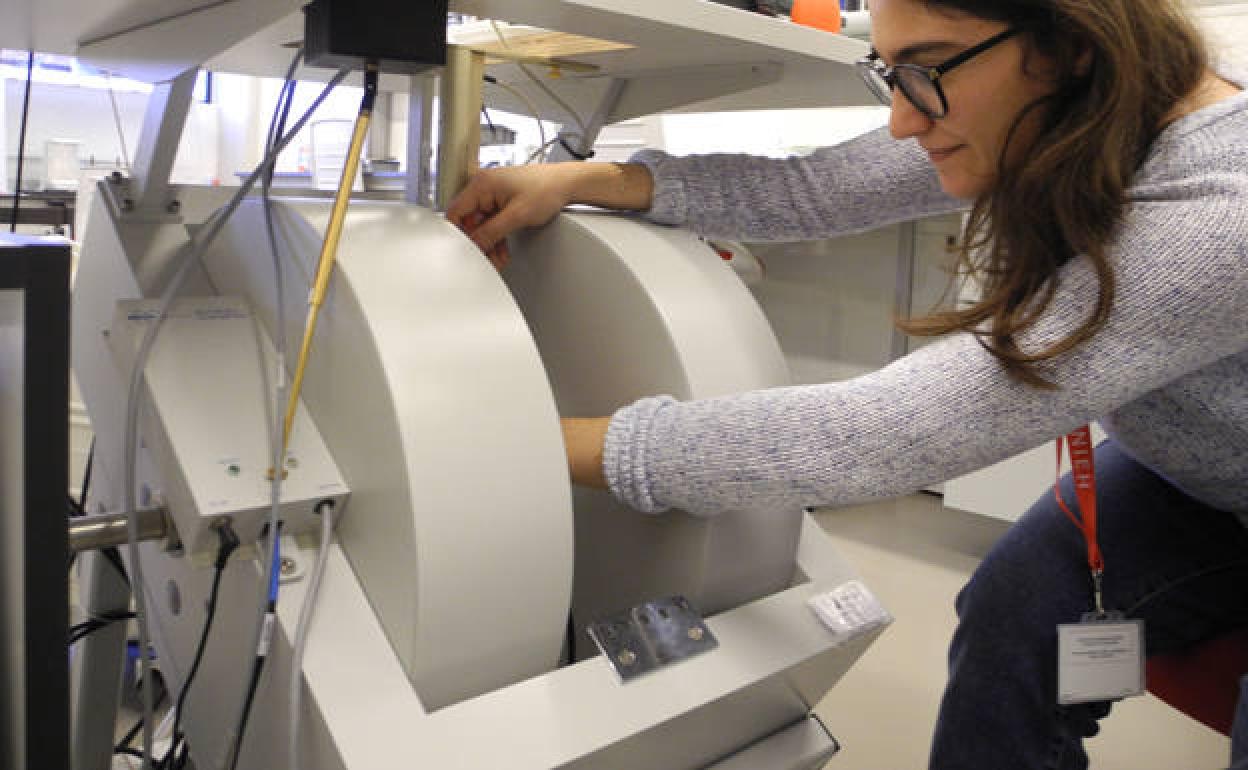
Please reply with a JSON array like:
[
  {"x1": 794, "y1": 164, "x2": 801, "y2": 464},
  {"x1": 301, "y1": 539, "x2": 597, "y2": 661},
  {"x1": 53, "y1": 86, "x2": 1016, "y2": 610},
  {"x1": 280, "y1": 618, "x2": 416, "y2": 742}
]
[{"x1": 447, "y1": 0, "x2": 1248, "y2": 770}]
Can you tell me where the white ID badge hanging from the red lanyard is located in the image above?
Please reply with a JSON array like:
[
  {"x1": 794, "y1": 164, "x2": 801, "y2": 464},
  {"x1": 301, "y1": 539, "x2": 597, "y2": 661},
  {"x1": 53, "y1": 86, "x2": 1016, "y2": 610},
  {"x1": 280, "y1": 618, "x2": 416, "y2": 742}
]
[{"x1": 1057, "y1": 613, "x2": 1144, "y2": 705}]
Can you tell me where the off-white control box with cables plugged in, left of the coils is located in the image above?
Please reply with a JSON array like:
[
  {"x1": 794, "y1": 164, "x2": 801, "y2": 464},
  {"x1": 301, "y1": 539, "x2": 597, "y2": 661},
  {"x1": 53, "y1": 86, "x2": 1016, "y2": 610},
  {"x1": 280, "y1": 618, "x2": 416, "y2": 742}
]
[{"x1": 109, "y1": 297, "x2": 348, "y2": 559}]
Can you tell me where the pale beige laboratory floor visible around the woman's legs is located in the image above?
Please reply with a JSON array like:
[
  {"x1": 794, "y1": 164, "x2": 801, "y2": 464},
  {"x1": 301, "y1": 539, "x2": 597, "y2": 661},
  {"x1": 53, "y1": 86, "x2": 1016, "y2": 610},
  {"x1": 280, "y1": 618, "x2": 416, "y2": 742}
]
[{"x1": 817, "y1": 494, "x2": 1229, "y2": 770}]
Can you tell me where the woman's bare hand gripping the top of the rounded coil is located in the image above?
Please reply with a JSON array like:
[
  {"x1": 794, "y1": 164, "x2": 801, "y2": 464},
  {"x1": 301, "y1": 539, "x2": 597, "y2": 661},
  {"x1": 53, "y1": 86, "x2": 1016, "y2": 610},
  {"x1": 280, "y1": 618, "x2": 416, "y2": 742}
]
[{"x1": 447, "y1": 162, "x2": 654, "y2": 268}]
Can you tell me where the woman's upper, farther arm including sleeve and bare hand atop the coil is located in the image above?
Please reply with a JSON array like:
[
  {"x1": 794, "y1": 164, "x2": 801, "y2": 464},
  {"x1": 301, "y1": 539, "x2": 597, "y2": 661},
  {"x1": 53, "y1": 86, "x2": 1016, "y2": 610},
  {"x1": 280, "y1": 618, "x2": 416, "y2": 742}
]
[{"x1": 447, "y1": 130, "x2": 963, "y2": 258}]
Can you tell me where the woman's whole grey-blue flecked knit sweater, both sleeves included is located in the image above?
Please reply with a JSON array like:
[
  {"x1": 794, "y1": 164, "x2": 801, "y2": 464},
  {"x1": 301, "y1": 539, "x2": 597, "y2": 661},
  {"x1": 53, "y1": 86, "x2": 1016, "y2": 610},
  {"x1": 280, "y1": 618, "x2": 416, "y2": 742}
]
[{"x1": 604, "y1": 72, "x2": 1248, "y2": 519}]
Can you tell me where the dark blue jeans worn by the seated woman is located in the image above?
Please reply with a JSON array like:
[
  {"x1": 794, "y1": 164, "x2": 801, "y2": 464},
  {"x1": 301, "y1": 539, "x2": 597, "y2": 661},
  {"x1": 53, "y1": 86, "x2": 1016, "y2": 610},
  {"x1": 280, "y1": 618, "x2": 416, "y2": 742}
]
[{"x1": 930, "y1": 441, "x2": 1248, "y2": 770}]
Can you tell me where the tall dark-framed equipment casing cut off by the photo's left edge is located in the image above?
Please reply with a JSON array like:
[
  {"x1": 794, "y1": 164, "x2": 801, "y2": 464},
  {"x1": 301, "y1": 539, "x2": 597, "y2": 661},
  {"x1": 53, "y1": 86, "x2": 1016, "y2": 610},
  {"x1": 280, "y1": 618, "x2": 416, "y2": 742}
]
[{"x1": 0, "y1": 232, "x2": 71, "y2": 770}]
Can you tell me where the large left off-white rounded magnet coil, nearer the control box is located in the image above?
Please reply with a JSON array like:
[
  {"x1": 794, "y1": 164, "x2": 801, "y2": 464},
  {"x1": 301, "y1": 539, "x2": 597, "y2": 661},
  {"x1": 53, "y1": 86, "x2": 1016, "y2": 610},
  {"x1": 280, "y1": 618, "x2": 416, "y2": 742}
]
[{"x1": 205, "y1": 200, "x2": 573, "y2": 710}]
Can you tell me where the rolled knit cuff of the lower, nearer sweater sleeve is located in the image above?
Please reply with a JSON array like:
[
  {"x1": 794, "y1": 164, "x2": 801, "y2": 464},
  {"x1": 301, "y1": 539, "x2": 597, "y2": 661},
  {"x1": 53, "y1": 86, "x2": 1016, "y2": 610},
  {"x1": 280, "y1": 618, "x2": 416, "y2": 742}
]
[{"x1": 603, "y1": 396, "x2": 676, "y2": 513}]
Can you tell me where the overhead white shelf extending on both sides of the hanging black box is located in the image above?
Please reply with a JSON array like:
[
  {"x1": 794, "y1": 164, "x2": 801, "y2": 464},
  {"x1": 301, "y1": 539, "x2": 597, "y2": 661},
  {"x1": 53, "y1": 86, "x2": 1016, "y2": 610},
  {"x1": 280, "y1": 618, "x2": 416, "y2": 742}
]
[{"x1": 0, "y1": 0, "x2": 870, "y2": 117}]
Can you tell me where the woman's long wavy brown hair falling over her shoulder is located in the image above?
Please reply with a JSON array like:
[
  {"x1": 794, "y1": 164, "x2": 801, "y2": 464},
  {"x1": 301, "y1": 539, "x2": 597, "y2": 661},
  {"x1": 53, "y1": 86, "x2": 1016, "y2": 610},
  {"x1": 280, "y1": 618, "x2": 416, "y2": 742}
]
[{"x1": 900, "y1": 0, "x2": 1208, "y2": 387}]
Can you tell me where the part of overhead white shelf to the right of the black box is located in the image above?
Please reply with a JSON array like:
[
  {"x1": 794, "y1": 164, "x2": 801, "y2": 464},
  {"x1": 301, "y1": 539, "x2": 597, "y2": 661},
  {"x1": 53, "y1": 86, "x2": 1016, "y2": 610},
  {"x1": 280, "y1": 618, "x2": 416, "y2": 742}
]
[{"x1": 452, "y1": 0, "x2": 875, "y2": 115}]
